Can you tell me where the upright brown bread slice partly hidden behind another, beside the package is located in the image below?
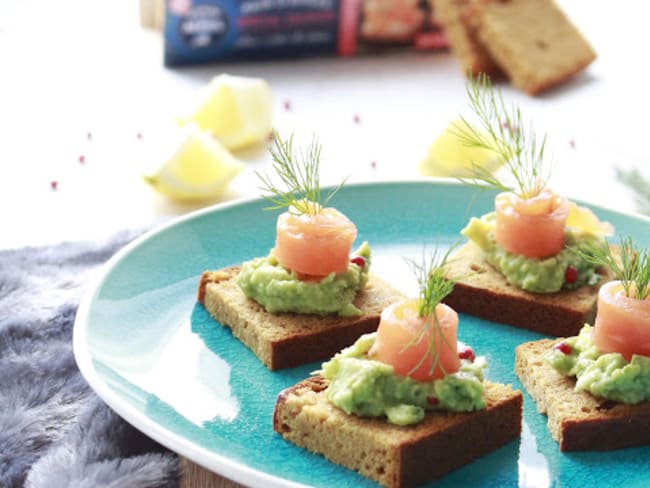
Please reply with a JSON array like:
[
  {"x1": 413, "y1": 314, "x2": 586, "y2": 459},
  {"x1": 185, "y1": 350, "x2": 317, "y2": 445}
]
[{"x1": 429, "y1": 0, "x2": 503, "y2": 76}]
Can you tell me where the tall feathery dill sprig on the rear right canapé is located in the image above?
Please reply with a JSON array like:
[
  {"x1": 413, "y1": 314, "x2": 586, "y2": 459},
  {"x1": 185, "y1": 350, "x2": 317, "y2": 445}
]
[{"x1": 452, "y1": 73, "x2": 550, "y2": 198}]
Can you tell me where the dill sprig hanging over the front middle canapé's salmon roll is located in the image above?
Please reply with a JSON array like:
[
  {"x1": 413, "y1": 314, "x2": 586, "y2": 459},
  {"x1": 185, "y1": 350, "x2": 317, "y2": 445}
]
[{"x1": 404, "y1": 246, "x2": 455, "y2": 375}]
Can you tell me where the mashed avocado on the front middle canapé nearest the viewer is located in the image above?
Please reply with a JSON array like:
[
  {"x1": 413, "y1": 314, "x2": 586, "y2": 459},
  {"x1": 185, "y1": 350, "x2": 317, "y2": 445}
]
[{"x1": 319, "y1": 332, "x2": 486, "y2": 425}]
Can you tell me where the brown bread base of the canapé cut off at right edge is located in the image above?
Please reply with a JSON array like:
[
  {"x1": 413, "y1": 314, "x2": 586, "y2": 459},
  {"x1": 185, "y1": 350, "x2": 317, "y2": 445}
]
[{"x1": 515, "y1": 339, "x2": 650, "y2": 451}]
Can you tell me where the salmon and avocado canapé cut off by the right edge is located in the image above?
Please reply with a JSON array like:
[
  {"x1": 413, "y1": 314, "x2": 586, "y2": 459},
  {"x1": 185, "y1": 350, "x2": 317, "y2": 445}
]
[{"x1": 515, "y1": 238, "x2": 650, "y2": 451}]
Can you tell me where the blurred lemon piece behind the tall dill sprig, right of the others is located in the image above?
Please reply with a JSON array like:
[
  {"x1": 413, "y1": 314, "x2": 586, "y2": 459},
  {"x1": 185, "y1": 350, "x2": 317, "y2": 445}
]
[{"x1": 418, "y1": 120, "x2": 503, "y2": 178}]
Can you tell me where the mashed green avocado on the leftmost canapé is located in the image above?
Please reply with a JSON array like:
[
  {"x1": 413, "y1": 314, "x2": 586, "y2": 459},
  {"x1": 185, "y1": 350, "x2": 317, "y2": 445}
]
[{"x1": 237, "y1": 242, "x2": 370, "y2": 317}]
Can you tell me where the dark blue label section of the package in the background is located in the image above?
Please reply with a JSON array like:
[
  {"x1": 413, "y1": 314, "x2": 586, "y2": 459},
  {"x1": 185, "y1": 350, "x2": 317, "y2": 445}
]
[{"x1": 165, "y1": 0, "x2": 339, "y2": 65}]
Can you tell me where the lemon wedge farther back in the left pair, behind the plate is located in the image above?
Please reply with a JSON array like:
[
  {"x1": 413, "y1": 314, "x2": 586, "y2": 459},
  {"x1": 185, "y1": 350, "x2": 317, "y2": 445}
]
[{"x1": 180, "y1": 74, "x2": 273, "y2": 150}]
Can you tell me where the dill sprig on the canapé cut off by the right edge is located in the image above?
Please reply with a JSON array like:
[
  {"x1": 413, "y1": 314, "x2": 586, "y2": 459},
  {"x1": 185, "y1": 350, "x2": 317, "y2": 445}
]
[{"x1": 580, "y1": 236, "x2": 650, "y2": 300}]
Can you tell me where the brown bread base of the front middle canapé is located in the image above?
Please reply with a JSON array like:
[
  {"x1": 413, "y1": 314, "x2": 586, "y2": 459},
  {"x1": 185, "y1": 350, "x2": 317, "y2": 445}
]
[{"x1": 273, "y1": 376, "x2": 522, "y2": 488}]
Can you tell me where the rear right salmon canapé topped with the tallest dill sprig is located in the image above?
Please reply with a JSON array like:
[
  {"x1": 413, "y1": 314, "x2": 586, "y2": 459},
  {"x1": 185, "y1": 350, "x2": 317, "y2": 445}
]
[{"x1": 447, "y1": 76, "x2": 613, "y2": 335}]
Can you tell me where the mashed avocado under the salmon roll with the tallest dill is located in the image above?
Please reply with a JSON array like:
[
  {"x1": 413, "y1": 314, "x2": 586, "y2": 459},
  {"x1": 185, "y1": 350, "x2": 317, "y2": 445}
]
[{"x1": 461, "y1": 212, "x2": 600, "y2": 293}]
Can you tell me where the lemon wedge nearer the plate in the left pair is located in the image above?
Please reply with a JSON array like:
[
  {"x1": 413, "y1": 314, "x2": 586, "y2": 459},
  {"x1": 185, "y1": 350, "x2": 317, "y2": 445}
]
[{"x1": 143, "y1": 123, "x2": 244, "y2": 200}]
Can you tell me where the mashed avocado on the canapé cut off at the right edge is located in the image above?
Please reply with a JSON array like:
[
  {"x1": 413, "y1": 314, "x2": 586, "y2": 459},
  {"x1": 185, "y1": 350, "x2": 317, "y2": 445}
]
[{"x1": 547, "y1": 325, "x2": 650, "y2": 403}]
